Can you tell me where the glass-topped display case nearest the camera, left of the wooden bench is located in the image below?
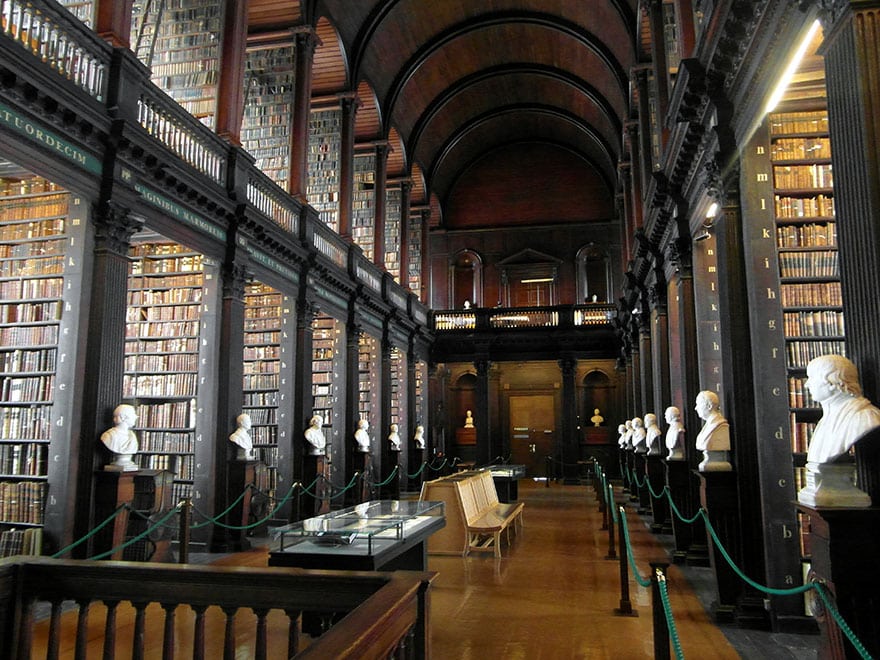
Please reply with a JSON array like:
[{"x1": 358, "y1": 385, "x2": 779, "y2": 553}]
[{"x1": 269, "y1": 500, "x2": 446, "y2": 571}]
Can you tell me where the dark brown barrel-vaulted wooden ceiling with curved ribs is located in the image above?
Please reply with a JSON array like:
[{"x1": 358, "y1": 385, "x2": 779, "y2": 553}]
[{"x1": 248, "y1": 0, "x2": 648, "y2": 227}]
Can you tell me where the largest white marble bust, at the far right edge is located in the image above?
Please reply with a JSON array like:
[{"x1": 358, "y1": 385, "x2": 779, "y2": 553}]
[{"x1": 798, "y1": 355, "x2": 880, "y2": 507}]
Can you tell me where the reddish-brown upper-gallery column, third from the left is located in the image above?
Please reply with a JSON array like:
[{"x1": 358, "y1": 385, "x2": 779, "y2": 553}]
[{"x1": 288, "y1": 29, "x2": 318, "y2": 199}]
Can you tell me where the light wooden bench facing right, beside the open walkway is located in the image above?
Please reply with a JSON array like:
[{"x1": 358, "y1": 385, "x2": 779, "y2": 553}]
[{"x1": 455, "y1": 472, "x2": 525, "y2": 557}]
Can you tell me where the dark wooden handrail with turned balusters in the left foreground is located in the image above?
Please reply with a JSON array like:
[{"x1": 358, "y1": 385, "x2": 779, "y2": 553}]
[{"x1": 0, "y1": 557, "x2": 434, "y2": 658}]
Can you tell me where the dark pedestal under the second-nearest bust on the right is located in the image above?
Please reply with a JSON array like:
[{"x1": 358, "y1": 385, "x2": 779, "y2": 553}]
[{"x1": 697, "y1": 471, "x2": 742, "y2": 622}]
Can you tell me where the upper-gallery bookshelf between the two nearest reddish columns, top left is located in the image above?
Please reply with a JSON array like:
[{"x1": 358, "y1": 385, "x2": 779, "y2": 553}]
[{"x1": 131, "y1": 0, "x2": 224, "y2": 128}]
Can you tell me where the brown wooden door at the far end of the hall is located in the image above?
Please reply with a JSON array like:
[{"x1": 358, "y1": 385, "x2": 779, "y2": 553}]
[{"x1": 510, "y1": 394, "x2": 556, "y2": 477}]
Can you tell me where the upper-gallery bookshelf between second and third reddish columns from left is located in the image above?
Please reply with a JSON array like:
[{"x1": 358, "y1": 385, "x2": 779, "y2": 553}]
[{"x1": 241, "y1": 46, "x2": 296, "y2": 190}]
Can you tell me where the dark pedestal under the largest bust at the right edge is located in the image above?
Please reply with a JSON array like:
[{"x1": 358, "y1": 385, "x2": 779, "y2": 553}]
[{"x1": 797, "y1": 504, "x2": 880, "y2": 658}]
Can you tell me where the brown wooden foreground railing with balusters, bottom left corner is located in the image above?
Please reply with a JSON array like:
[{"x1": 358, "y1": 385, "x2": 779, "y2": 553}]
[{"x1": 0, "y1": 556, "x2": 434, "y2": 660}]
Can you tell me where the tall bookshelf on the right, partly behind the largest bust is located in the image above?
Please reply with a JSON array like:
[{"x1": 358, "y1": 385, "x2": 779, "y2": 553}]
[{"x1": 767, "y1": 109, "x2": 846, "y2": 588}]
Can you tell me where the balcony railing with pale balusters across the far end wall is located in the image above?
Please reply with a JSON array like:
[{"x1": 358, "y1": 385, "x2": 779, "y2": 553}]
[{"x1": 434, "y1": 303, "x2": 617, "y2": 332}]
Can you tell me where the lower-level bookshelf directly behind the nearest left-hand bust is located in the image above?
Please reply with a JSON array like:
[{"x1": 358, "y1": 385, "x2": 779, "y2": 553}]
[{"x1": 123, "y1": 240, "x2": 216, "y2": 501}]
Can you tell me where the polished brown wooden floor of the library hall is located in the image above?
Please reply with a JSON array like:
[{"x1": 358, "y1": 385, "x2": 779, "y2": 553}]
[{"x1": 34, "y1": 481, "x2": 764, "y2": 660}]
